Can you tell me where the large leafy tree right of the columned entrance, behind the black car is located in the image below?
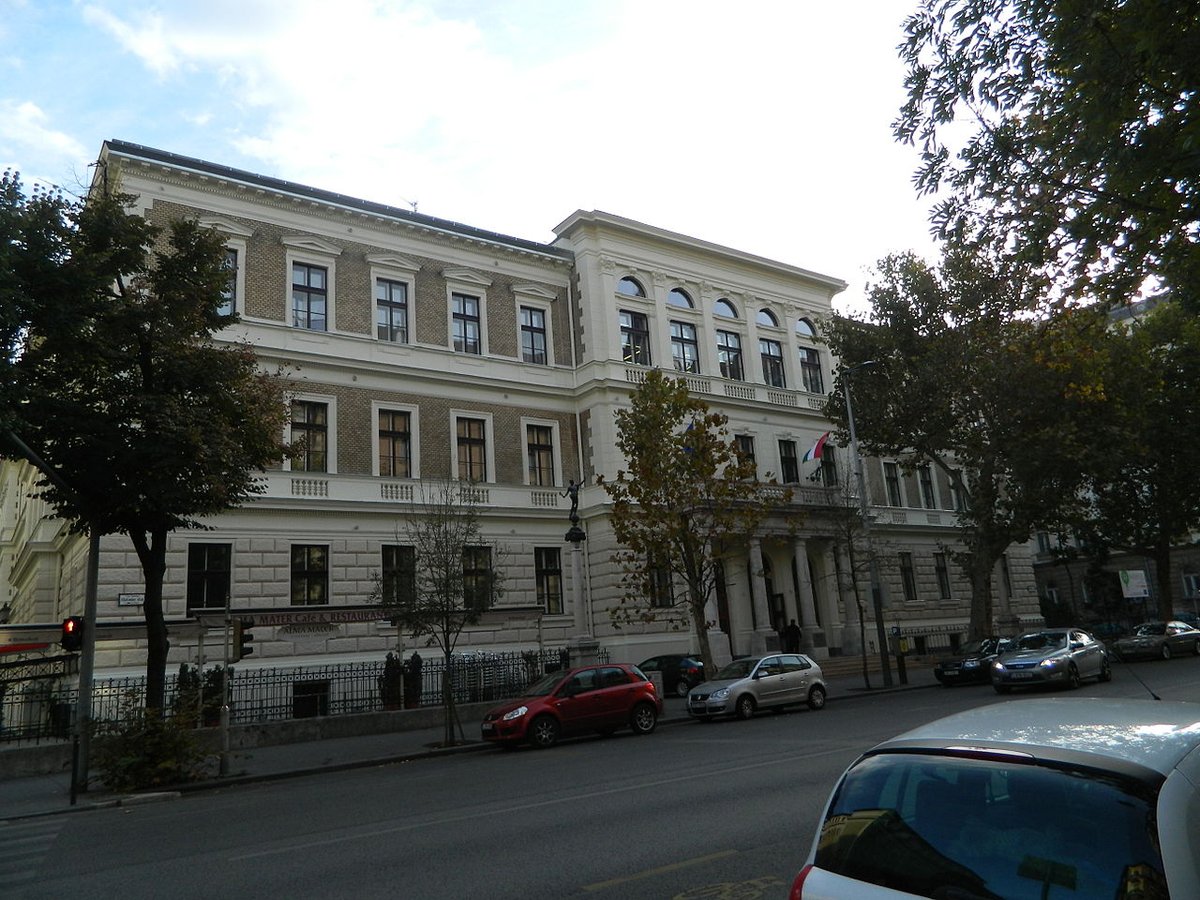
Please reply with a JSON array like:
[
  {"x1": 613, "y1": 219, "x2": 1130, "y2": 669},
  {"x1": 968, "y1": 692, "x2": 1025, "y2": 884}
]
[{"x1": 826, "y1": 247, "x2": 1106, "y2": 640}]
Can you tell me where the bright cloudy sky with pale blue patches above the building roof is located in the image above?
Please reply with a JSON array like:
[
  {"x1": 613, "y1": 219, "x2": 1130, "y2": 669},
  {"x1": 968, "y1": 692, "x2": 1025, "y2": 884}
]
[{"x1": 0, "y1": 0, "x2": 934, "y2": 313}]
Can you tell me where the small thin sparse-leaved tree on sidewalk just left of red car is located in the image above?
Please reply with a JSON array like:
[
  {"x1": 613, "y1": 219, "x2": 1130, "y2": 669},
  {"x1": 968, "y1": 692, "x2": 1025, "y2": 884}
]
[{"x1": 371, "y1": 479, "x2": 504, "y2": 746}]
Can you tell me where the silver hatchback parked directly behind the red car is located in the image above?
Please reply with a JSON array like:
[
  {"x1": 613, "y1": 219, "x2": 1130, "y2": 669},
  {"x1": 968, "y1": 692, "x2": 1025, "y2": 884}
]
[{"x1": 688, "y1": 653, "x2": 826, "y2": 721}]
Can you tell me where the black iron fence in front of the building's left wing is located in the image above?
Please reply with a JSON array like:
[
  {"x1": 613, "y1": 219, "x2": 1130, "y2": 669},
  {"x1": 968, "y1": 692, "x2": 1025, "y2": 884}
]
[{"x1": 0, "y1": 648, "x2": 607, "y2": 744}]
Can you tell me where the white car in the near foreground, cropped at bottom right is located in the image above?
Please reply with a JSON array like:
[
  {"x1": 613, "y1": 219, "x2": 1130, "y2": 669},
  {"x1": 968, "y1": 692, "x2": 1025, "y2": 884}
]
[{"x1": 790, "y1": 697, "x2": 1200, "y2": 900}]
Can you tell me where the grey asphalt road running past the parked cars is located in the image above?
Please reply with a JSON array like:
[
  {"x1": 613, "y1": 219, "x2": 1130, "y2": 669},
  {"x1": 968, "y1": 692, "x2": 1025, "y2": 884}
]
[{"x1": 7, "y1": 658, "x2": 1200, "y2": 900}]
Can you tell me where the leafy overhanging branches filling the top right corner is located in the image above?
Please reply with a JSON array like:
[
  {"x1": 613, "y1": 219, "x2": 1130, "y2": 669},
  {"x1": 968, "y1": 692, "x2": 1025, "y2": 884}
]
[{"x1": 893, "y1": 0, "x2": 1200, "y2": 304}]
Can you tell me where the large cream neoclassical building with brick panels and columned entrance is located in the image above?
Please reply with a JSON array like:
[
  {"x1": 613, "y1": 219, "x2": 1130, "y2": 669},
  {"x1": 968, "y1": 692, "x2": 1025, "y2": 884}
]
[{"x1": 0, "y1": 140, "x2": 1038, "y2": 668}]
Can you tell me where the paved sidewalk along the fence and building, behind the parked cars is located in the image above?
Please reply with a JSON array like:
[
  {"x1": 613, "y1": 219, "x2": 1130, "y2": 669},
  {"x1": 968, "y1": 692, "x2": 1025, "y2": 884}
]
[{"x1": 0, "y1": 666, "x2": 937, "y2": 822}]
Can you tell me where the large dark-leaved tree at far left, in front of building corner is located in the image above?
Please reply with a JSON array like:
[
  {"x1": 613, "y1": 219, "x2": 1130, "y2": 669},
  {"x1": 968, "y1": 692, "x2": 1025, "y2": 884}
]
[{"x1": 0, "y1": 175, "x2": 287, "y2": 710}]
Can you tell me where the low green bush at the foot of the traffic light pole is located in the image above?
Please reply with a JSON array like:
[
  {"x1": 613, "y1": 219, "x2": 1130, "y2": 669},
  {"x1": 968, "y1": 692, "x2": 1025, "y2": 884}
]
[{"x1": 91, "y1": 695, "x2": 208, "y2": 791}]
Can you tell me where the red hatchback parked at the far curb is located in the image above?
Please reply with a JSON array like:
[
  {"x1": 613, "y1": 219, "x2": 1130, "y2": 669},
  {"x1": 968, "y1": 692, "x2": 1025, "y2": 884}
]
[{"x1": 482, "y1": 664, "x2": 662, "y2": 748}]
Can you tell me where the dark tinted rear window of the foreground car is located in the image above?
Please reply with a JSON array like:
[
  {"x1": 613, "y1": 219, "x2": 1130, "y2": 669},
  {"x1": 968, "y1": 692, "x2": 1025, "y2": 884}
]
[{"x1": 816, "y1": 754, "x2": 1169, "y2": 900}]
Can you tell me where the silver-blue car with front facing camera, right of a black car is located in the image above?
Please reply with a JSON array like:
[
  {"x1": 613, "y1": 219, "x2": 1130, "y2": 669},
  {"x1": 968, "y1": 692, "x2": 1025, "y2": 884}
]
[{"x1": 991, "y1": 628, "x2": 1112, "y2": 694}]
